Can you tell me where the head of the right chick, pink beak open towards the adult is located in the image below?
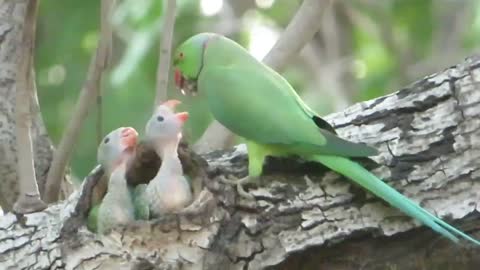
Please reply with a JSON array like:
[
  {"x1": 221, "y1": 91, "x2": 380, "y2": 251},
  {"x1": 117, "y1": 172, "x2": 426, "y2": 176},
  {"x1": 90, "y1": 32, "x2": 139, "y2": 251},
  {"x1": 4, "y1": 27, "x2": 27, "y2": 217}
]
[{"x1": 145, "y1": 99, "x2": 188, "y2": 142}]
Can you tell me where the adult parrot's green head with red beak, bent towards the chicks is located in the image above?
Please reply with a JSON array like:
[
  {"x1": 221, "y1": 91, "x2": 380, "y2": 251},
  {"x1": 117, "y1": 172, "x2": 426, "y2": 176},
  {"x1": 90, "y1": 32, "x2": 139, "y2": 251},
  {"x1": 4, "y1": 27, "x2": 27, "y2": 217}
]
[{"x1": 173, "y1": 33, "x2": 217, "y2": 95}]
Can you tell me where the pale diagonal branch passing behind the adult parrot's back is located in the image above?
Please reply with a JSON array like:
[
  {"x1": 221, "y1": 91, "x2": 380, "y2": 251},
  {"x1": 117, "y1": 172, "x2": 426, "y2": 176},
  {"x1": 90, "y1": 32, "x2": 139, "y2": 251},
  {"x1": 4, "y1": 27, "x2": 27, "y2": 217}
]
[{"x1": 193, "y1": 0, "x2": 331, "y2": 153}]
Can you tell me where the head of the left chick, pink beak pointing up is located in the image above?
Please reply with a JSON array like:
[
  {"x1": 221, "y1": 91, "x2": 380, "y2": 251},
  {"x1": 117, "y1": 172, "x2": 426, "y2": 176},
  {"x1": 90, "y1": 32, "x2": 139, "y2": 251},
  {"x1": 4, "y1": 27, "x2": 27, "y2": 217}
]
[{"x1": 97, "y1": 127, "x2": 138, "y2": 172}]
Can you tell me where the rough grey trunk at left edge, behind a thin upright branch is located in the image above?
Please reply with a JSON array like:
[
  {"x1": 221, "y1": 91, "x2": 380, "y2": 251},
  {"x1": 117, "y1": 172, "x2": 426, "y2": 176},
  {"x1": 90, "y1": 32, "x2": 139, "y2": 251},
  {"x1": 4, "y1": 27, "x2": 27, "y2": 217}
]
[{"x1": 0, "y1": 0, "x2": 71, "y2": 211}]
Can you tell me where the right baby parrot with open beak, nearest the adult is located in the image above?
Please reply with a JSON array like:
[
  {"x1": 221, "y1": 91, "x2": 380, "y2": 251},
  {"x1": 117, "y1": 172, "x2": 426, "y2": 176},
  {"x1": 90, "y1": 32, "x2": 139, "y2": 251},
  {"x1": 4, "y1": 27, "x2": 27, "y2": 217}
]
[{"x1": 145, "y1": 100, "x2": 193, "y2": 217}]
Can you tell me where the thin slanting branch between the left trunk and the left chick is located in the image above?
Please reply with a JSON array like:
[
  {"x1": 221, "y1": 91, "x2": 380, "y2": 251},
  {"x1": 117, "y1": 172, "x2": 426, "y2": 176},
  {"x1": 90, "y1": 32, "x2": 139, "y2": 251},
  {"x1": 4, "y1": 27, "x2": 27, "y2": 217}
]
[{"x1": 45, "y1": 0, "x2": 115, "y2": 203}]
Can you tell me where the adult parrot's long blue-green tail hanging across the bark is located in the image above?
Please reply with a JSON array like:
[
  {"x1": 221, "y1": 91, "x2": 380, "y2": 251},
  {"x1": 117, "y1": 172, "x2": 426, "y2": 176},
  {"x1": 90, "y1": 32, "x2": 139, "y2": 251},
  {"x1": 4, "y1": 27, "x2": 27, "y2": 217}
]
[{"x1": 310, "y1": 155, "x2": 480, "y2": 246}]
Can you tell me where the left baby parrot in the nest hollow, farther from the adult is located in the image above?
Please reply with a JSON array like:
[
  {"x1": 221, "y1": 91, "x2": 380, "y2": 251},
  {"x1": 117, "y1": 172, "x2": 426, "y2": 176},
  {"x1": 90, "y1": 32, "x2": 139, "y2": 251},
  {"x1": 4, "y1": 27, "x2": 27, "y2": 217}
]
[{"x1": 97, "y1": 127, "x2": 138, "y2": 233}]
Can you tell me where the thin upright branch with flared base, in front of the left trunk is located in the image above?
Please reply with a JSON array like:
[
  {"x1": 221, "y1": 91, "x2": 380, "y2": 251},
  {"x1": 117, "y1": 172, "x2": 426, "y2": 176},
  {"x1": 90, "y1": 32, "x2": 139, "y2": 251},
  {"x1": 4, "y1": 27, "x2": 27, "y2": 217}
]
[{"x1": 13, "y1": 0, "x2": 47, "y2": 214}]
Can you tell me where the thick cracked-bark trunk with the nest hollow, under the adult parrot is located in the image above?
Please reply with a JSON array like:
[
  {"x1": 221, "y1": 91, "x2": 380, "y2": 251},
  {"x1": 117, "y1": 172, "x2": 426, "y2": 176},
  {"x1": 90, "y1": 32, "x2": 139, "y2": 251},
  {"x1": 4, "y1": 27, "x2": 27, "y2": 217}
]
[{"x1": 0, "y1": 56, "x2": 480, "y2": 270}]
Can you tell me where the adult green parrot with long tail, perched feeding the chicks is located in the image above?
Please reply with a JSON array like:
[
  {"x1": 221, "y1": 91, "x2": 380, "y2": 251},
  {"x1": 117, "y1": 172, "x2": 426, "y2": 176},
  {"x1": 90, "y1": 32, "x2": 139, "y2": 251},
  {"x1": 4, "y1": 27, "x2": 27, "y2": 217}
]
[{"x1": 173, "y1": 33, "x2": 480, "y2": 245}]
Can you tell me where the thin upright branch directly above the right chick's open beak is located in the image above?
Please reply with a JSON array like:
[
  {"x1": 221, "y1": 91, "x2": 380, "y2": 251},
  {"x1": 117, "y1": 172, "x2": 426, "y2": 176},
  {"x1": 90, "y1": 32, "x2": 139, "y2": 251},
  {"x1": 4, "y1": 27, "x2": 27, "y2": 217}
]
[{"x1": 155, "y1": 0, "x2": 176, "y2": 106}]
